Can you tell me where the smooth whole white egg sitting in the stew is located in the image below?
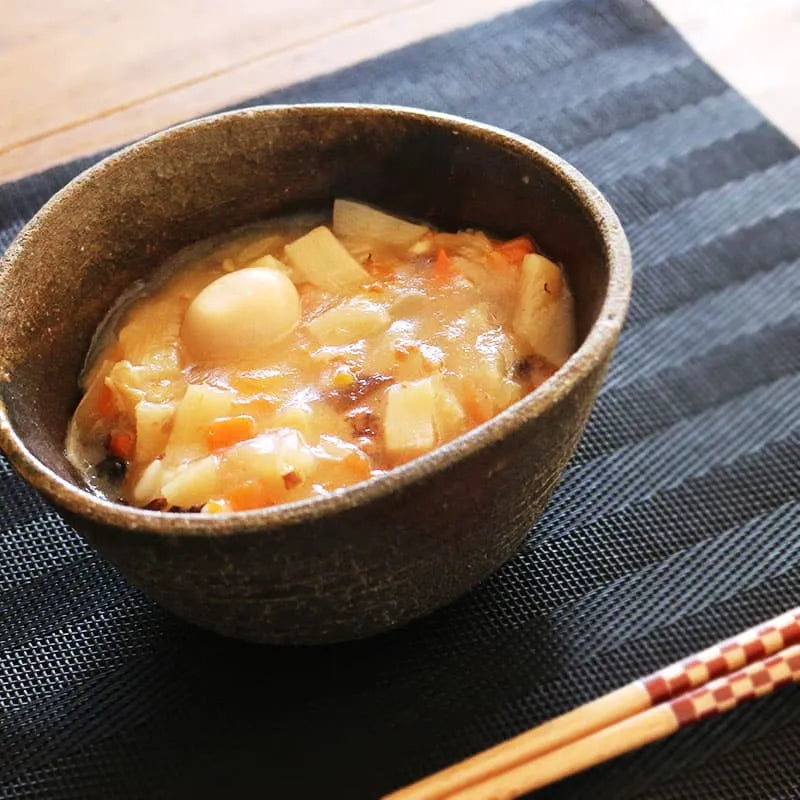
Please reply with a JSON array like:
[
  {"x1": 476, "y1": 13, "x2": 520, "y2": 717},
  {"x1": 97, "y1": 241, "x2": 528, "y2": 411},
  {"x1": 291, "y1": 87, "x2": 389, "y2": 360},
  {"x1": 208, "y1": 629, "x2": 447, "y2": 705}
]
[{"x1": 181, "y1": 267, "x2": 300, "y2": 361}]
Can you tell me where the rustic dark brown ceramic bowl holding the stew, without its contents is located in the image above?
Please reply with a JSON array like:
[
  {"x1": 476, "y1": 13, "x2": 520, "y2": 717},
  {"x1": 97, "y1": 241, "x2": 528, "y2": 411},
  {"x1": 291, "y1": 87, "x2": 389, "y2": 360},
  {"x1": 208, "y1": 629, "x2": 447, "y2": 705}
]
[{"x1": 0, "y1": 105, "x2": 631, "y2": 643}]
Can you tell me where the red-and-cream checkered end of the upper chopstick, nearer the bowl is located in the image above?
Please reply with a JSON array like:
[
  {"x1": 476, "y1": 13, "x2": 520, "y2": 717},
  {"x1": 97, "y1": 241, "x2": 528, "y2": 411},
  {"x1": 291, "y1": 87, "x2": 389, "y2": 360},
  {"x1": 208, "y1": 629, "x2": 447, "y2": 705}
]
[{"x1": 641, "y1": 608, "x2": 800, "y2": 705}]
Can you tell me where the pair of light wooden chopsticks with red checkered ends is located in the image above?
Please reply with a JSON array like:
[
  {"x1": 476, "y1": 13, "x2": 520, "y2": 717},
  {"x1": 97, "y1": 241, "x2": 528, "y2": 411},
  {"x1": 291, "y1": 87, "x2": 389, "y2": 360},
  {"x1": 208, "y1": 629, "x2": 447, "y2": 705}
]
[{"x1": 384, "y1": 607, "x2": 800, "y2": 800}]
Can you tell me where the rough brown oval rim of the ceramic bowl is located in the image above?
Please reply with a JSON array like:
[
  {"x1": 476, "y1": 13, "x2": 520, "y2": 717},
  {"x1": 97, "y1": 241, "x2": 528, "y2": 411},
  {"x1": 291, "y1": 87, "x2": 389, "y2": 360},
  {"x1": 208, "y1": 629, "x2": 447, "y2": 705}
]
[{"x1": 0, "y1": 103, "x2": 632, "y2": 537}]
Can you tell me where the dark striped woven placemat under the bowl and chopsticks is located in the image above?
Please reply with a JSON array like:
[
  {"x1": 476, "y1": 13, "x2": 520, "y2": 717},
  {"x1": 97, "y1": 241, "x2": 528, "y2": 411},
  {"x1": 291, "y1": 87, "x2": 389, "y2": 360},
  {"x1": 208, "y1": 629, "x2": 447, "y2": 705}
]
[{"x1": 0, "y1": 0, "x2": 800, "y2": 800}]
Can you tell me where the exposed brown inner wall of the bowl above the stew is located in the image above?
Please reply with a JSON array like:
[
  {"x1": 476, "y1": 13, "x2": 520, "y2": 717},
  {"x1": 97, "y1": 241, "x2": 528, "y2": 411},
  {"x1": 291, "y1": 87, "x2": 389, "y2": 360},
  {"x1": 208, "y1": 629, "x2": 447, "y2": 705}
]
[{"x1": 0, "y1": 107, "x2": 609, "y2": 494}]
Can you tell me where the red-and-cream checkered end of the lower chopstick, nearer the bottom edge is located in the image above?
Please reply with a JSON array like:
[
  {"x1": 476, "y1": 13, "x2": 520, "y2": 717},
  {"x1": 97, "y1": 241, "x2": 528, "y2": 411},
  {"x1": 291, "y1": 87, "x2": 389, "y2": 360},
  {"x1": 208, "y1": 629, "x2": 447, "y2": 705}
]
[{"x1": 669, "y1": 645, "x2": 800, "y2": 728}]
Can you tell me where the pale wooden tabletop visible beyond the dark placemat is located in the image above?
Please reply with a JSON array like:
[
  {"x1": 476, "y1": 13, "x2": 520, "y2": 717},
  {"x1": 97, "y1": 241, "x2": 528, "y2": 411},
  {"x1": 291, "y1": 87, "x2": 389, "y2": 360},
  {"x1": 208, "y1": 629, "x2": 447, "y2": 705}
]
[{"x1": 0, "y1": 0, "x2": 800, "y2": 181}]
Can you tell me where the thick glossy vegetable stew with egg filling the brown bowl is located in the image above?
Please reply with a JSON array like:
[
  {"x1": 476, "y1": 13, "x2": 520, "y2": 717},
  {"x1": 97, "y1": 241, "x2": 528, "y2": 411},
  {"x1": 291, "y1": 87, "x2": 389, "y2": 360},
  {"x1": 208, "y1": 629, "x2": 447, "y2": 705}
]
[{"x1": 67, "y1": 200, "x2": 575, "y2": 513}]
